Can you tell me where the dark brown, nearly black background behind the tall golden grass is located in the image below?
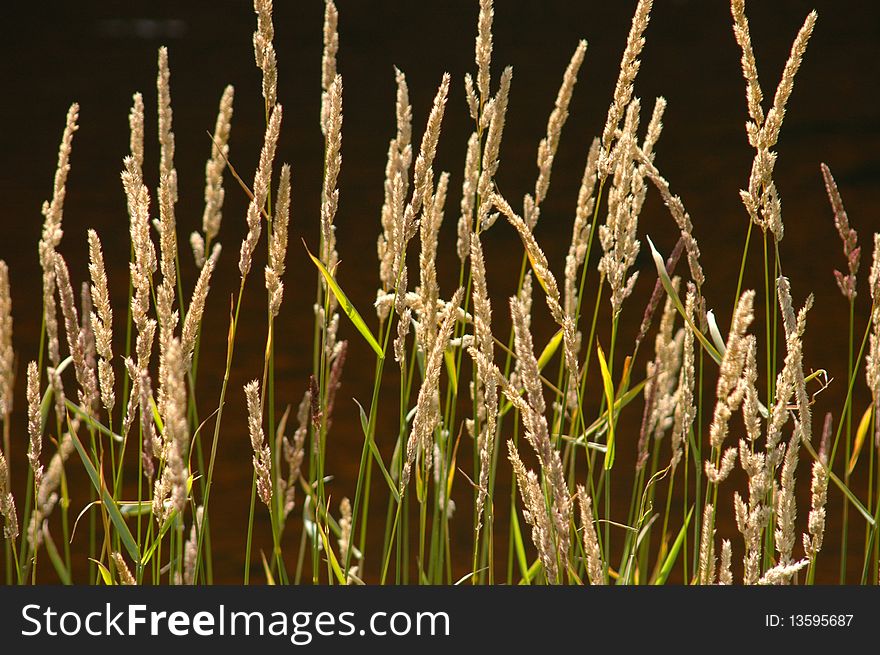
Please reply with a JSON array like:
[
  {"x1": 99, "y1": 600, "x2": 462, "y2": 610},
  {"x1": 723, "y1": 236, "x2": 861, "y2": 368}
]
[{"x1": 0, "y1": 0, "x2": 880, "y2": 581}]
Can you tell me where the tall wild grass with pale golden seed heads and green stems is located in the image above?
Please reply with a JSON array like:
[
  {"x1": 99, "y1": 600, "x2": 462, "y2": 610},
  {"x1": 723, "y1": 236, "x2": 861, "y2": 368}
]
[{"x1": 0, "y1": 0, "x2": 880, "y2": 585}]
